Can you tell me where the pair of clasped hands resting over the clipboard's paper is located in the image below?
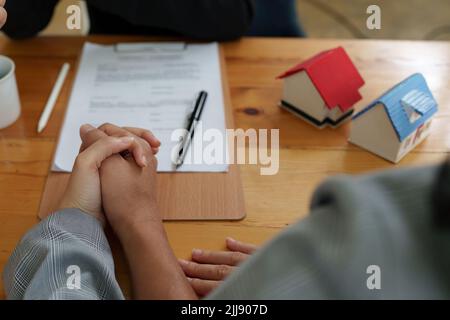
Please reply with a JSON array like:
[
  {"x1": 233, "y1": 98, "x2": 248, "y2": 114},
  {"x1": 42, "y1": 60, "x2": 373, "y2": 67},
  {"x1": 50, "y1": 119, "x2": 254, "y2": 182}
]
[{"x1": 60, "y1": 124, "x2": 161, "y2": 236}]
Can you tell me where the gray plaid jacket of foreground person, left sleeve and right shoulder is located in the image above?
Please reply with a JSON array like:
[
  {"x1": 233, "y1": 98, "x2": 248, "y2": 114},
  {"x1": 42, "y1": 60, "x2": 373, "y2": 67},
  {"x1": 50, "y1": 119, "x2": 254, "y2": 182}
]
[{"x1": 3, "y1": 166, "x2": 450, "y2": 299}]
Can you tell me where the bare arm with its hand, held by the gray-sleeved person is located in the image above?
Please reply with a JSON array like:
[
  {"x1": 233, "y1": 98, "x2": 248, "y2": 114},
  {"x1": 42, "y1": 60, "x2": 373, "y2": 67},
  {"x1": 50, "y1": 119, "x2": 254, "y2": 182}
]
[{"x1": 82, "y1": 124, "x2": 196, "y2": 299}]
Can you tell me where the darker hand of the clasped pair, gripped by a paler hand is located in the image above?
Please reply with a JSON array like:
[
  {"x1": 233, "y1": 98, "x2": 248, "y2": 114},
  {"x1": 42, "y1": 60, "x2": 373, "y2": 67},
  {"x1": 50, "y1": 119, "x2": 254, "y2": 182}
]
[{"x1": 78, "y1": 124, "x2": 161, "y2": 235}]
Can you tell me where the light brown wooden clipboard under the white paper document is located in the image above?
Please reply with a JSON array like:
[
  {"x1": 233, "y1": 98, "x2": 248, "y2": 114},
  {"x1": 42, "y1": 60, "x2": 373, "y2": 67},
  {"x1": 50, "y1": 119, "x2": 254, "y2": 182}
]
[{"x1": 38, "y1": 46, "x2": 246, "y2": 221}]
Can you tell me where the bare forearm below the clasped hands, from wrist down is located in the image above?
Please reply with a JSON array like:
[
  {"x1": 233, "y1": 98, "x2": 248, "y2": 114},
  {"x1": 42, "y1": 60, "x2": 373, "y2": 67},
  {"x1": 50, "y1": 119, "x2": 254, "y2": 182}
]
[{"x1": 118, "y1": 215, "x2": 196, "y2": 300}]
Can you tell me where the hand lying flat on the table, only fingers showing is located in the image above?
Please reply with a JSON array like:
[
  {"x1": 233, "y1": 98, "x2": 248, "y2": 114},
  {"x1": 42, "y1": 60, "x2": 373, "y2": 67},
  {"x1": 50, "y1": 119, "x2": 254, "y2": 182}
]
[{"x1": 179, "y1": 238, "x2": 257, "y2": 297}]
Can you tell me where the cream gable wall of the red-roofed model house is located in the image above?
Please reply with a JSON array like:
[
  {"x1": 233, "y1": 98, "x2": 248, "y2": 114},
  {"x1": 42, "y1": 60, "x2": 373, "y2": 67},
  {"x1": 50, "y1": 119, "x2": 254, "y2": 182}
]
[{"x1": 283, "y1": 71, "x2": 351, "y2": 126}]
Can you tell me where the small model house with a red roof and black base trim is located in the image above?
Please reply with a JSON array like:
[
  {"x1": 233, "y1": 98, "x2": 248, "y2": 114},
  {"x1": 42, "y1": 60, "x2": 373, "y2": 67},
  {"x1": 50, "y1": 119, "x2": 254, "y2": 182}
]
[{"x1": 278, "y1": 47, "x2": 364, "y2": 128}]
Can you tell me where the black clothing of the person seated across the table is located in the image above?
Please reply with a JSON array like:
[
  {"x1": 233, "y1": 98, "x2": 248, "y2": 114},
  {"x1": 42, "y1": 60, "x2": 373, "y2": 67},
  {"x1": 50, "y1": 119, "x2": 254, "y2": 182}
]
[{"x1": 3, "y1": 0, "x2": 254, "y2": 41}]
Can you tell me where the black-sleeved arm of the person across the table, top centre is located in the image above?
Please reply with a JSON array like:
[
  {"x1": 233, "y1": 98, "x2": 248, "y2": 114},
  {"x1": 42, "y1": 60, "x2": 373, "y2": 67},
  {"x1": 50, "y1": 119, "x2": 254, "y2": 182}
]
[{"x1": 88, "y1": 0, "x2": 254, "y2": 40}]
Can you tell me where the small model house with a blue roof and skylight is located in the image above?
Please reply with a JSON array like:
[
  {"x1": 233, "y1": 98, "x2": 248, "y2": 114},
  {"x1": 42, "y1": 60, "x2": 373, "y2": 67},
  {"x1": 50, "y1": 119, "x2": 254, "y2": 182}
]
[{"x1": 350, "y1": 73, "x2": 437, "y2": 163}]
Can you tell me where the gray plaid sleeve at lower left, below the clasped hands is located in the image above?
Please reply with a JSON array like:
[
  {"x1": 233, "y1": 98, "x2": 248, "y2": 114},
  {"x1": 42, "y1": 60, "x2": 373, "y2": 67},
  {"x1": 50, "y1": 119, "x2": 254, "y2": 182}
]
[{"x1": 3, "y1": 209, "x2": 124, "y2": 300}]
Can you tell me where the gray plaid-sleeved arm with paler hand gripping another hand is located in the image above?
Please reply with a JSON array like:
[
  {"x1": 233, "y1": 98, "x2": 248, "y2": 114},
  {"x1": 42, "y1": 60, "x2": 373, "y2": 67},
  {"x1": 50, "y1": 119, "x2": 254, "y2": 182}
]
[{"x1": 3, "y1": 125, "x2": 156, "y2": 299}]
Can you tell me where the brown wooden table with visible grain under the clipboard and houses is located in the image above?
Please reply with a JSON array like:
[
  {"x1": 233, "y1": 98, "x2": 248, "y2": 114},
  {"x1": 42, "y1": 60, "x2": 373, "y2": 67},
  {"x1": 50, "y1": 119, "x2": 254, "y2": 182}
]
[{"x1": 0, "y1": 37, "x2": 450, "y2": 297}]
